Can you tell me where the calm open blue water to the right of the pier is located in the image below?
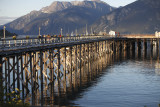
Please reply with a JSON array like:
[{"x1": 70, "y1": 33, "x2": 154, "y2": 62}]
[{"x1": 66, "y1": 49, "x2": 160, "y2": 107}]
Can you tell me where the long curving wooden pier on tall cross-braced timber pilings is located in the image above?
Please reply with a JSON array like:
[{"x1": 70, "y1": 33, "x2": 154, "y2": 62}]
[{"x1": 0, "y1": 36, "x2": 159, "y2": 106}]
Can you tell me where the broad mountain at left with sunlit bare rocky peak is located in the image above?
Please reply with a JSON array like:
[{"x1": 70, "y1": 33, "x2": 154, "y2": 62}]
[{"x1": 2, "y1": 0, "x2": 115, "y2": 34}]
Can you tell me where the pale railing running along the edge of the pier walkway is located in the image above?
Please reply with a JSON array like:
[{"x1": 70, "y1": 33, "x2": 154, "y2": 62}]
[{"x1": 0, "y1": 36, "x2": 108, "y2": 50}]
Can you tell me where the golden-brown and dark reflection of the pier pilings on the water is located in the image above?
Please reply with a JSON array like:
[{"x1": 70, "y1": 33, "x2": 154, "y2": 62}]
[{"x1": 45, "y1": 46, "x2": 113, "y2": 106}]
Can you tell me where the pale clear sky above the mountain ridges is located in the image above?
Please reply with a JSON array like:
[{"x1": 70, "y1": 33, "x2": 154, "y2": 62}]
[{"x1": 0, "y1": 0, "x2": 136, "y2": 18}]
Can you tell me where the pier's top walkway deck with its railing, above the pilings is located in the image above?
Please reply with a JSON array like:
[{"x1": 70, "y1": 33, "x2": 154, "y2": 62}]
[{"x1": 0, "y1": 36, "x2": 127, "y2": 55}]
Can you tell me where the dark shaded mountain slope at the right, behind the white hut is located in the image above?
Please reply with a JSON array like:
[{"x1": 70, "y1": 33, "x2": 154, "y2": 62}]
[{"x1": 92, "y1": 0, "x2": 160, "y2": 34}]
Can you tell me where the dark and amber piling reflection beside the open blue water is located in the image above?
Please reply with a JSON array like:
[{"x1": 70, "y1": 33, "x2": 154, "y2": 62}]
[{"x1": 54, "y1": 54, "x2": 113, "y2": 106}]
